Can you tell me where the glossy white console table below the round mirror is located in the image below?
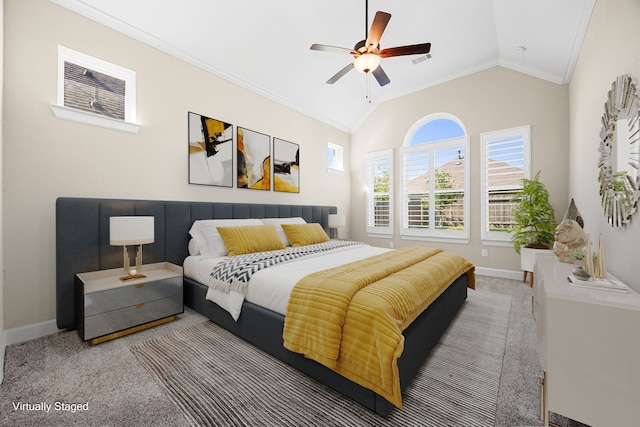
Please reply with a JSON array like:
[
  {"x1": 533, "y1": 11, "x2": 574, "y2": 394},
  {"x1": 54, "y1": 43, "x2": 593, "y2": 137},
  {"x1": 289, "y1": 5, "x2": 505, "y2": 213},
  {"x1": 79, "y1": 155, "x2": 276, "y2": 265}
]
[{"x1": 533, "y1": 256, "x2": 640, "y2": 427}]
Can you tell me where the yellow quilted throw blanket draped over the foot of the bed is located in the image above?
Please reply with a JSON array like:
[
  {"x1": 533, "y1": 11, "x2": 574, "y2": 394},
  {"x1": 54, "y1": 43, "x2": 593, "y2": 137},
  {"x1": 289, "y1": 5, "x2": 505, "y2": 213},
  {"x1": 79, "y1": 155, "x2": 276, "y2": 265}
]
[{"x1": 283, "y1": 248, "x2": 474, "y2": 407}]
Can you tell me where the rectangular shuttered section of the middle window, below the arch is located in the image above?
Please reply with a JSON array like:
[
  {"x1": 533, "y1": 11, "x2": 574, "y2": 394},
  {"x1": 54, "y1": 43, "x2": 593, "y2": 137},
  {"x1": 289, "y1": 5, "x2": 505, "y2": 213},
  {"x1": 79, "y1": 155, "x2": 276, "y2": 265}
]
[{"x1": 402, "y1": 137, "x2": 469, "y2": 239}]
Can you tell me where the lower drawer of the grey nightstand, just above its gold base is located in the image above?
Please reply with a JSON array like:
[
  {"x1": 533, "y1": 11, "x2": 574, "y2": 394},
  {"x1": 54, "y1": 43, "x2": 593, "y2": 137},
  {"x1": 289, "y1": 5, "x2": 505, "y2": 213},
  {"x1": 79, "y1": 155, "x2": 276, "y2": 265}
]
[{"x1": 83, "y1": 289, "x2": 183, "y2": 340}]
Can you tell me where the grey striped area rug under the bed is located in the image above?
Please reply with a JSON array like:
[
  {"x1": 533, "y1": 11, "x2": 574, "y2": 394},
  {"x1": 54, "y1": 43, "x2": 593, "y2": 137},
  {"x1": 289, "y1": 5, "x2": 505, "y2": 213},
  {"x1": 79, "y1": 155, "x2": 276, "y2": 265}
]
[{"x1": 131, "y1": 290, "x2": 511, "y2": 427}]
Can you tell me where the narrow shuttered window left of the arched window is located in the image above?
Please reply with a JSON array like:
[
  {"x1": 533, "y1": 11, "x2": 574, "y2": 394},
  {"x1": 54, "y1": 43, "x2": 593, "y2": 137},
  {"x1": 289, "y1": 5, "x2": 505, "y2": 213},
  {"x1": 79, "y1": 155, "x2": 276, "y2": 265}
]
[{"x1": 367, "y1": 150, "x2": 393, "y2": 236}]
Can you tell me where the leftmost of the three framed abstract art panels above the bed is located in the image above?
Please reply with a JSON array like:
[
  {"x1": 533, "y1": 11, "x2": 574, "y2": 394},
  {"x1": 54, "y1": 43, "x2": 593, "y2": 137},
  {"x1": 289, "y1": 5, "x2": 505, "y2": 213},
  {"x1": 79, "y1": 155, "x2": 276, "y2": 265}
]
[{"x1": 189, "y1": 112, "x2": 233, "y2": 187}]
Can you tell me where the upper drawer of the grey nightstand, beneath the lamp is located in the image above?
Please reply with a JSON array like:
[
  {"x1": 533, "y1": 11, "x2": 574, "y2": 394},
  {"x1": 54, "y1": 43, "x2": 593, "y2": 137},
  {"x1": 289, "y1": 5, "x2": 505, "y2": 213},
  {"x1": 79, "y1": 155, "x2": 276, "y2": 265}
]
[{"x1": 84, "y1": 276, "x2": 182, "y2": 316}]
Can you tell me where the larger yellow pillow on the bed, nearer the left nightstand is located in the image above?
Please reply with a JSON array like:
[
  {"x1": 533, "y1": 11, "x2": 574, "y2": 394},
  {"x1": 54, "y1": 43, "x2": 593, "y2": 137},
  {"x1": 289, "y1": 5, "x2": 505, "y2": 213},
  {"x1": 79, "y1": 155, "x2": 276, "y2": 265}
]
[{"x1": 218, "y1": 224, "x2": 284, "y2": 256}]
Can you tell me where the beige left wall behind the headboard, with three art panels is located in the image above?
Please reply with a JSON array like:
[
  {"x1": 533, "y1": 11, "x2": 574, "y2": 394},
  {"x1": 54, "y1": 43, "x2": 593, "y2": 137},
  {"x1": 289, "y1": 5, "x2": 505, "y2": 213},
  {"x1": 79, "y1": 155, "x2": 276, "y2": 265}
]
[{"x1": 3, "y1": 0, "x2": 350, "y2": 329}]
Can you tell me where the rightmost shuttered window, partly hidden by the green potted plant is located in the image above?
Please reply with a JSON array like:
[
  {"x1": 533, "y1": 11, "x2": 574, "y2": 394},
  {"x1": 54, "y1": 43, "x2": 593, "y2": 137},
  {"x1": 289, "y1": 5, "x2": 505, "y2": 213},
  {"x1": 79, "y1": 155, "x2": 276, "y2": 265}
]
[{"x1": 481, "y1": 125, "x2": 531, "y2": 243}]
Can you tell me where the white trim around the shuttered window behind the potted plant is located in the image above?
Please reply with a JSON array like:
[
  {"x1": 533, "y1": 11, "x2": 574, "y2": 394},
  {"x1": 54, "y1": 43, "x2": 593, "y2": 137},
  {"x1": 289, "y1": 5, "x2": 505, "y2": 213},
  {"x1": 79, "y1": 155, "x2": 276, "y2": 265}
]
[{"x1": 480, "y1": 125, "x2": 531, "y2": 246}]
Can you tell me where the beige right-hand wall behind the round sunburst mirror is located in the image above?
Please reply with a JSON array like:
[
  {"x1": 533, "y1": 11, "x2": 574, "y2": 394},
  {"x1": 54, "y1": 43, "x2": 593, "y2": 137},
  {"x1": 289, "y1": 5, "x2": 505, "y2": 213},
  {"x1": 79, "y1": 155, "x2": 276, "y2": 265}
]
[{"x1": 570, "y1": 0, "x2": 640, "y2": 291}]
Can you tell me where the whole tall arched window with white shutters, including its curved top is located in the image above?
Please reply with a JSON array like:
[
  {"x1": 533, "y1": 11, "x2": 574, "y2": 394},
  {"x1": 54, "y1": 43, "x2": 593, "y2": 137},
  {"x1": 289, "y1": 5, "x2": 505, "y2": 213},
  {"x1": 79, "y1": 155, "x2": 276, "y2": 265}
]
[{"x1": 401, "y1": 113, "x2": 470, "y2": 243}]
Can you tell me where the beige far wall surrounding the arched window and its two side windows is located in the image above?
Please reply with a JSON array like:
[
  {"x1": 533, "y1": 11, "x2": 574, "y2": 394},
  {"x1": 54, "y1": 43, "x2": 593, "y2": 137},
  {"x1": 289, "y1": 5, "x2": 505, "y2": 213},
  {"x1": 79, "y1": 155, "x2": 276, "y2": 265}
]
[{"x1": 350, "y1": 67, "x2": 569, "y2": 271}]
